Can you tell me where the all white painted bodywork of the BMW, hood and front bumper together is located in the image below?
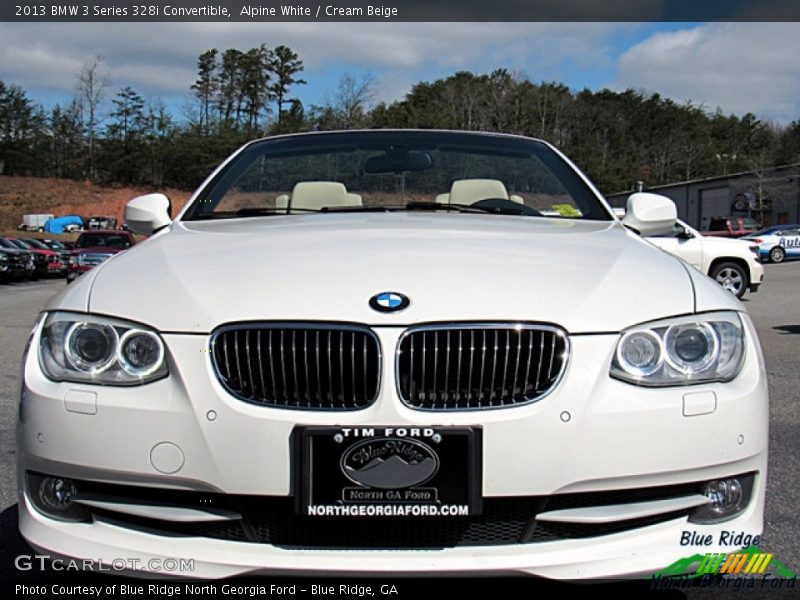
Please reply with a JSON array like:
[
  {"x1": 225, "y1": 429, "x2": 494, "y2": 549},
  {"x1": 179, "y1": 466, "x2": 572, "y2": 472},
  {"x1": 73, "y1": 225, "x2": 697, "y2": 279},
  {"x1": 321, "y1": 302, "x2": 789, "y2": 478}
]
[{"x1": 17, "y1": 131, "x2": 768, "y2": 579}]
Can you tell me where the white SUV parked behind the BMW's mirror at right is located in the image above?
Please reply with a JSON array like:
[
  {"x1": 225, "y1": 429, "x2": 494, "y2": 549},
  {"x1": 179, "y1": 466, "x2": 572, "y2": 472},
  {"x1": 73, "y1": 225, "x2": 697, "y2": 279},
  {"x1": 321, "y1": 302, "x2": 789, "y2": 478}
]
[{"x1": 647, "y1": 219, "x2": 764, "y2": 298}]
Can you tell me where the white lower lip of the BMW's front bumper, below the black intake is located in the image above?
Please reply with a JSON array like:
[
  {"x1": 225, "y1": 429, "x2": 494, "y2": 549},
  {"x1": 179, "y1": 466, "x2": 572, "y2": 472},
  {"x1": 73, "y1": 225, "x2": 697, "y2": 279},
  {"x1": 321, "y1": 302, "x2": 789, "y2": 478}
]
[{"x1": 20, "y1": 486, "x2": 764, "y2": 579}]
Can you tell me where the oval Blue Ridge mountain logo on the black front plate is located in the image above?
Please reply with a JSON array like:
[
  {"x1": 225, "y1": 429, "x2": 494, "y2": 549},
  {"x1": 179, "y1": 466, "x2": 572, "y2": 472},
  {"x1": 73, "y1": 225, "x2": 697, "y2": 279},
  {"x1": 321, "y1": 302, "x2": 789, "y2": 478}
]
[{"x1": 341, "y1": 438, "x2": 439, "y2": 490}]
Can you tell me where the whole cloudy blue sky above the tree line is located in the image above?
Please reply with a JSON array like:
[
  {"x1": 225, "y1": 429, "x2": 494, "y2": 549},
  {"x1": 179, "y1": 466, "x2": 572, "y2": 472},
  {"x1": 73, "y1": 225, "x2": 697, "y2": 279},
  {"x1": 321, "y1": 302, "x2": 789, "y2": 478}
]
[{"x1": 0, "y1": 23, "x2": 800, "y2": 123}]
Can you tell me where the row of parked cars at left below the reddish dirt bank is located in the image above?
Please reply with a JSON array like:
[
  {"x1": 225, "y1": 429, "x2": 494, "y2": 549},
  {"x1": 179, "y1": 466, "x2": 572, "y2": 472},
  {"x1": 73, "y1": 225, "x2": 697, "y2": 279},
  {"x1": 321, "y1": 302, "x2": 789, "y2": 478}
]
[{"x1": 0, "y1": 230, "x2": 136, "y2": 283}]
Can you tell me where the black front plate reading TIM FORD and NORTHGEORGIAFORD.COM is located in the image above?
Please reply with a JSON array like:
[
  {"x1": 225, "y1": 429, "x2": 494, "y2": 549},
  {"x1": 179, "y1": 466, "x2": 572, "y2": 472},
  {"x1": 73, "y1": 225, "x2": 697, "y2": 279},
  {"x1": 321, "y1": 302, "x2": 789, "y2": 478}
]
[{"x1": 294, "y1": 426, "x2": 481, "y2": 517}]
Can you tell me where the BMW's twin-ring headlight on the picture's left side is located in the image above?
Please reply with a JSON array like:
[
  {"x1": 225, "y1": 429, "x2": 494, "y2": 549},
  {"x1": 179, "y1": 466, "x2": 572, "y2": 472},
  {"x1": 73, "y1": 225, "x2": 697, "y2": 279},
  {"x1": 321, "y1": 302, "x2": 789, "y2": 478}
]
[{"x1": 39, "y1": 312, "x2": 168, "y2": 385}]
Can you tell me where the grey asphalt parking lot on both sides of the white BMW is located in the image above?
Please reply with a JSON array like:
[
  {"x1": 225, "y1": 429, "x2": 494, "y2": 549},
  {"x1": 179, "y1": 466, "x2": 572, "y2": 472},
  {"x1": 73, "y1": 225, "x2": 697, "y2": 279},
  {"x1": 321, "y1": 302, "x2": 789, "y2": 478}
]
[{"x1": 0, "y1": 262, "x2": 800, "y2": 584}]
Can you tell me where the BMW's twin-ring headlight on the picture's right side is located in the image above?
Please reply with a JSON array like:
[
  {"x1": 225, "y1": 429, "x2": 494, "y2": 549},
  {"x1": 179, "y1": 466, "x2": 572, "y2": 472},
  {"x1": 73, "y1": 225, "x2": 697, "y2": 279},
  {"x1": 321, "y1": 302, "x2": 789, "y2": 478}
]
[{"x1": 610, "y1": 312, "x2": 744, "y2": 386}]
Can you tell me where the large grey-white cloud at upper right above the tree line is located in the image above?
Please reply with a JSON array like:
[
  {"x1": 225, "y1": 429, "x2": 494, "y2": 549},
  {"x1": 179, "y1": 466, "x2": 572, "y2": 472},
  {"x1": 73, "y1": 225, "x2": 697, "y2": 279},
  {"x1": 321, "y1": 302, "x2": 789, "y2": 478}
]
[{"x1": 614, "y1": 23, "x2": 800, "y2": 122}]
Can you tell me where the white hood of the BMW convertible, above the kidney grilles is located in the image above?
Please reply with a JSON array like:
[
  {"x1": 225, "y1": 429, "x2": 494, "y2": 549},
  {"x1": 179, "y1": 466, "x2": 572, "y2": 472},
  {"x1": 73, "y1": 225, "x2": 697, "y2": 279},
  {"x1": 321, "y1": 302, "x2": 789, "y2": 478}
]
[{"x1": 87, "y1": 213, "x2": 704, "y2": 333}]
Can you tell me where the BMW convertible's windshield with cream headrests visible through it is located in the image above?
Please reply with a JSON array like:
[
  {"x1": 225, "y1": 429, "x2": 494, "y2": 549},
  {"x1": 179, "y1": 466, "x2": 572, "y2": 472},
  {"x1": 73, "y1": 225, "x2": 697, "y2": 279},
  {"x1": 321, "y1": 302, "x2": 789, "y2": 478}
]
[{"x1": 184, "y1": 130, "x2": 611, "y2": 220}]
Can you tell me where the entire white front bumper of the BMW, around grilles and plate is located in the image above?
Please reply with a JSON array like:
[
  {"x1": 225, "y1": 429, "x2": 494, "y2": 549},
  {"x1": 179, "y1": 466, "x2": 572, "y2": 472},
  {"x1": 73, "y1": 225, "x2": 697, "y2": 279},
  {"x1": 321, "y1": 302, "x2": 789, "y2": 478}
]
[{"x1": 17, "y1": 315, "x2": 768, "y2": 579}]
